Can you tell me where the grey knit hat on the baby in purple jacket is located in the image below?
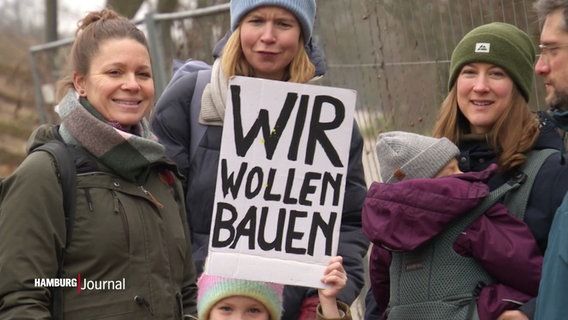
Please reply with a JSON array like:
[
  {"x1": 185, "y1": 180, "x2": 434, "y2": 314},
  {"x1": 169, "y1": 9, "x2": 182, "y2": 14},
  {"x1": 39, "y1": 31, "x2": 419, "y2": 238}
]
[{"x1": 377, "y1": 131, "x2": 460, "y2": 183}]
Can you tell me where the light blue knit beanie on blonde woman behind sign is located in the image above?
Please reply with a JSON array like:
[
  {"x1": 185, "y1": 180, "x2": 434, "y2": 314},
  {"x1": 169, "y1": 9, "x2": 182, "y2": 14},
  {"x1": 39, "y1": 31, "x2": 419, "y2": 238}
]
[{"x1": 231, "y1": 0, "x2": 316, "y2": 44}]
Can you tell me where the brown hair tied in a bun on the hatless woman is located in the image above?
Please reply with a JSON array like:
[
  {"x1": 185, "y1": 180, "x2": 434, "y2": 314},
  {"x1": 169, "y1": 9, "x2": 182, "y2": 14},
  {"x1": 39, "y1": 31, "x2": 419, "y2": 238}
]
[{"x1": 57, "y1": 8, "x2": 150, "y2": 100}]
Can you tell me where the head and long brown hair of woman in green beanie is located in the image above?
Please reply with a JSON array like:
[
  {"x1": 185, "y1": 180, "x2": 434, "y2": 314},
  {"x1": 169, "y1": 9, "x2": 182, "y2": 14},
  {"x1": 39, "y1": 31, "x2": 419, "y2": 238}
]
[{"x1": 434, "y1": 22, "x2": 540, "y2": 172}]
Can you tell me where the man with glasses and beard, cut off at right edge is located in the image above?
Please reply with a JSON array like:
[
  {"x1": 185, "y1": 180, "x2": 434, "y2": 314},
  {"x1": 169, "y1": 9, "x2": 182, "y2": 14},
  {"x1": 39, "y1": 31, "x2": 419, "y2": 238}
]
[{"x1": 534, "y1": 0, "x2": 568, "y2": 320}]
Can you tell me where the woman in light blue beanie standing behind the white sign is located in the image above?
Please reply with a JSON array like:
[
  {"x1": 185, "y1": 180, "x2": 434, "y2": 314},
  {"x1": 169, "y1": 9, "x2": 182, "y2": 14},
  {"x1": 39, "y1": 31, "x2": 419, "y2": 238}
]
[{"x1": 152, "y1": 0, "x2": 368, "y2": 319}]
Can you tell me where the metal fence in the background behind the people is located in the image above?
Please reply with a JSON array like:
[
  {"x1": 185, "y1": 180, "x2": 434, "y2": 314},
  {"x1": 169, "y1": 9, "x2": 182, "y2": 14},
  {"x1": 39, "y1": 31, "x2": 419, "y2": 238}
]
[{"x1": 29, "y1": 0, "x2": 543, "y2": 183}]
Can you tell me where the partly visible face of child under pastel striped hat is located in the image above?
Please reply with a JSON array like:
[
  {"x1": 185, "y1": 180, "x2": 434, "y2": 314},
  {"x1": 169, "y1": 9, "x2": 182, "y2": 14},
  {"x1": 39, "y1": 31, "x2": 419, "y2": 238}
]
[{"x1": 209, "y1": 296, "x2": 270, "y2": 320}]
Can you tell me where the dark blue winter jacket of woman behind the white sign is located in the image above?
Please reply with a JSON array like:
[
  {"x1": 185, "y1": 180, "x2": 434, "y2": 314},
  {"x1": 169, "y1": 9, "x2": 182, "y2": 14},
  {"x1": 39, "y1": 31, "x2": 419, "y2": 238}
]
[{"x1": 152, "y1": 30, "x2": 368, "y2": 320}]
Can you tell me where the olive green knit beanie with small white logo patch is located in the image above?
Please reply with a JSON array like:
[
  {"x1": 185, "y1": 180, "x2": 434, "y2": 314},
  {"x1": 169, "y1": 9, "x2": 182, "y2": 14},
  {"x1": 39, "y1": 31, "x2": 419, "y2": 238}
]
[{"x1": 448, "y1": 22, "x2": 536, "y2": 102}]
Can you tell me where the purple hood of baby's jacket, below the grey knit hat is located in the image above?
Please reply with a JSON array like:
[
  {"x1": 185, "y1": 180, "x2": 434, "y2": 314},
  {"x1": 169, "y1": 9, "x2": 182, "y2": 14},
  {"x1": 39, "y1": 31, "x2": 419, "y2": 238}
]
[{"x1": 362, "y1": 165, "x2": 497, "y2": 251}]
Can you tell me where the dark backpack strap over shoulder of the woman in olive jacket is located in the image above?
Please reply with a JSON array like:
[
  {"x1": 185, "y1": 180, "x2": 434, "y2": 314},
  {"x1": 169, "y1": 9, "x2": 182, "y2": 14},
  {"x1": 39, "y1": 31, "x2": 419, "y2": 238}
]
[{"x1": 31, "y1": 136, "x2": 76, "y2": 319}]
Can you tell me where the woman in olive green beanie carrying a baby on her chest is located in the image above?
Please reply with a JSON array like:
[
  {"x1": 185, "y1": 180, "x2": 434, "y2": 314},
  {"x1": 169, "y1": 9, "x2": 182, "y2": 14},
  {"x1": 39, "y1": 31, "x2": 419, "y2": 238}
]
[{"x1": 433, "y1": 22, "x2": 568, "y2": 319}]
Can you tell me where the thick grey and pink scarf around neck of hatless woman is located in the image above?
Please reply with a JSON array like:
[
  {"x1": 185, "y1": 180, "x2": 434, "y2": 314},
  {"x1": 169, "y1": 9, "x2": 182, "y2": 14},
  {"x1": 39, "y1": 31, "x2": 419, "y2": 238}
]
[{"x1": 56, "y1": 91, "x2": 165, "y2": 184}]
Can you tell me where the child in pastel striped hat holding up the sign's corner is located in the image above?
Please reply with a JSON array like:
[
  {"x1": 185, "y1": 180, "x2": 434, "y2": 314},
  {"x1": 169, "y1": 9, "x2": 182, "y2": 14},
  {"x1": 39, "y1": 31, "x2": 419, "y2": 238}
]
[{"x1": 197, "y1": 256, "x2": 351, "y2": 320}]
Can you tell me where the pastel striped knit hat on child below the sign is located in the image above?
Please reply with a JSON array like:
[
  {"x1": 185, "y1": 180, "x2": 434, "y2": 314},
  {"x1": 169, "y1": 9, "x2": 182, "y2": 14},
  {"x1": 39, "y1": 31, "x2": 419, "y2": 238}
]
[{"x1": 197, "y1": 273, "x2": 284, "y2": 320}]
